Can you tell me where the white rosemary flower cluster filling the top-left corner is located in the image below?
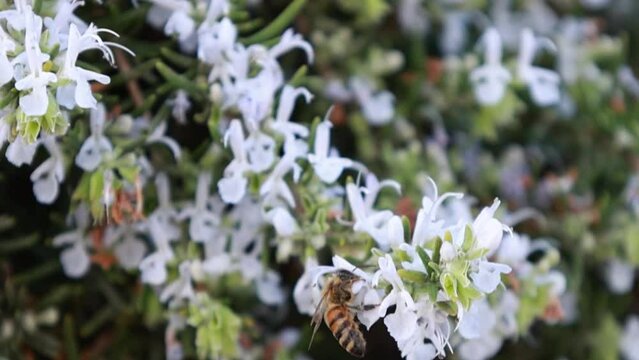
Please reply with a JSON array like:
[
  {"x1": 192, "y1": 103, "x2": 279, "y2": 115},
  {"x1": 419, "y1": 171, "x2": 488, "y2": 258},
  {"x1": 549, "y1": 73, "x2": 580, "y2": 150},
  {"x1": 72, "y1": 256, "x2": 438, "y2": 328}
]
[{"x1": 0, "y1": 0, "x2": 130, "y2": 204}]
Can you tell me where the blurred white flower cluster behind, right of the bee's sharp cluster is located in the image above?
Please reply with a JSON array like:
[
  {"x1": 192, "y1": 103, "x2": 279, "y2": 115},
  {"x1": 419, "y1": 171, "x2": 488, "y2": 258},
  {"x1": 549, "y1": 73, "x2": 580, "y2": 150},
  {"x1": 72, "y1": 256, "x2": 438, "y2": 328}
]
[{"x1": 456, "y1": 229, "x2": 569, "y2": 359}]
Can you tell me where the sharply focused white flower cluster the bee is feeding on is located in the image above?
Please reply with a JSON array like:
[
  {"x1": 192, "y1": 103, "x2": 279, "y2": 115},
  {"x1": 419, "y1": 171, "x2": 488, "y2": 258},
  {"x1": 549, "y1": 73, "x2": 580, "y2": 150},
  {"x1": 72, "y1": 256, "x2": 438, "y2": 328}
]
[{"x1": 294, "y1": 177, "x2": 512, "y2": 359}]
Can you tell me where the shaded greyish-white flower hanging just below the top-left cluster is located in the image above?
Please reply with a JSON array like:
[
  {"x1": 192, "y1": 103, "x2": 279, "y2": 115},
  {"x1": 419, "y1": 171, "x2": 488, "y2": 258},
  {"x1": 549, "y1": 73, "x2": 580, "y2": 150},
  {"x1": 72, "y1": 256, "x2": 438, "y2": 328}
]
[{"x1": 31, "y1": 136, "x2": 64, "y2": 204}]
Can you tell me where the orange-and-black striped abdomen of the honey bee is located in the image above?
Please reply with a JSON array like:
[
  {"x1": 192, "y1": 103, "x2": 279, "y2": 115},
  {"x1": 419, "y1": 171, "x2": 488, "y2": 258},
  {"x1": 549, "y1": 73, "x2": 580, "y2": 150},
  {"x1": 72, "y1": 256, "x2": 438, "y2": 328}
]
[{"x1": 324, "y1": 304, "x2": 366, "y2": 358}]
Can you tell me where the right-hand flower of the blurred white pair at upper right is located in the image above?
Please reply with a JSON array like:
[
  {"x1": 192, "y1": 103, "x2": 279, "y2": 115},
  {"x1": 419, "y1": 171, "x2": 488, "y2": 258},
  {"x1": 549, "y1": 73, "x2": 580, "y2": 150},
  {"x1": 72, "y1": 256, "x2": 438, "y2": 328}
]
[{"x1": 517, "y1": 29, "x2": 561, "y2": 106}]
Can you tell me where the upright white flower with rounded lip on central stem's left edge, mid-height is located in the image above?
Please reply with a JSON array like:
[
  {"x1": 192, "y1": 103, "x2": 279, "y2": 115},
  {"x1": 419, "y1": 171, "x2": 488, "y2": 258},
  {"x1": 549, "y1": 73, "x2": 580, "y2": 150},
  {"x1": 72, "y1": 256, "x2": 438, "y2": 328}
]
[{"x1": 217, "y1": 120, "x2": 250, "y2": 204}]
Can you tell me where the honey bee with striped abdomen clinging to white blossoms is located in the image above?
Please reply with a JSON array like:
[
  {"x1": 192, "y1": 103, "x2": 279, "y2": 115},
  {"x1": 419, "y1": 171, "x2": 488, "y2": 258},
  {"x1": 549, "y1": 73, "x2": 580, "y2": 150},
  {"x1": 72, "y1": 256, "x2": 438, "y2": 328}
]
[{"x1": 308, "y1": 270, "x2": 366, "y2": 358}]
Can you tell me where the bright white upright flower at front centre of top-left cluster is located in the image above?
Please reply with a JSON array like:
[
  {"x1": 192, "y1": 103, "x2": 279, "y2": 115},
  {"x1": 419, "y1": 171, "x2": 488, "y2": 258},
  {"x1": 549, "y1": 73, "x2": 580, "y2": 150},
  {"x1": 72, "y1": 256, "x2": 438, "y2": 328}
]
[{"x1": 14, "y1": 6, "x2": 57, "y2": 116}]
